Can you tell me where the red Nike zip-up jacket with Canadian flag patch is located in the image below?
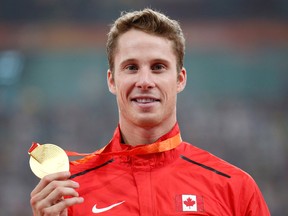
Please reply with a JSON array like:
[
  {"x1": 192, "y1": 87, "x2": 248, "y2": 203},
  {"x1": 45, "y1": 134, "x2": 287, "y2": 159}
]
[{"x1": 69, "y1": 124, "x2": 270, "y2": 216}]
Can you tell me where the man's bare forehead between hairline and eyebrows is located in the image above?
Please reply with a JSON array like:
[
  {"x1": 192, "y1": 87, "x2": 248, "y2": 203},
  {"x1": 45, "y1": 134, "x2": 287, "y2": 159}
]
[{"x1": 115, "y1": 29, "x2": 176, "y2": 63}]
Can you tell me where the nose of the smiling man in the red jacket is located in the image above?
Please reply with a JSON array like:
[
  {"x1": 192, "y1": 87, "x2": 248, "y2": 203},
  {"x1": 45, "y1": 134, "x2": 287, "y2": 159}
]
[{"x1": 136, "y1": 69, "x2": 155, "y2": 90}]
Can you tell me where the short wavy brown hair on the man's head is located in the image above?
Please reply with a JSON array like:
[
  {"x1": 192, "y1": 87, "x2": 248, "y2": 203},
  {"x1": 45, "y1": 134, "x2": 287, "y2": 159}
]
[{"x1": 106, "y1": 8, "x2": 185, "y2": 73}]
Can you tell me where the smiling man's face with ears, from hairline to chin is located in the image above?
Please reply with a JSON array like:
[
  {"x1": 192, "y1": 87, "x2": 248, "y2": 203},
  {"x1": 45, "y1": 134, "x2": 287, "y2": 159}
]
[{"x1": 108, "y1": 29, "x2": 186, "y2": 127}]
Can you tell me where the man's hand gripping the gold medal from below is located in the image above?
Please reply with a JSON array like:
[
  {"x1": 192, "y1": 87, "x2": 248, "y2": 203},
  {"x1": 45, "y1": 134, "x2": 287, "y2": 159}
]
[{"x1": 30, "y1": 172, "x2": 84, "y2": 216}]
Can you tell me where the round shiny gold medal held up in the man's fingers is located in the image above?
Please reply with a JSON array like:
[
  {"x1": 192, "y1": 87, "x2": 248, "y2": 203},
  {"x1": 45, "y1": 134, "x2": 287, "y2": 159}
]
[{"x1": 28, "y1": 143, "x2": 69, "y2": 178}]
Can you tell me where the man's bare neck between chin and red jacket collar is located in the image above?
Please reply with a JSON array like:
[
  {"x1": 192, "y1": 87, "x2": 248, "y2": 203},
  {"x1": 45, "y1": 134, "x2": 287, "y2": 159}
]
[{"x1": 120, "y1": 120, "x2": 176, "y2": 146}]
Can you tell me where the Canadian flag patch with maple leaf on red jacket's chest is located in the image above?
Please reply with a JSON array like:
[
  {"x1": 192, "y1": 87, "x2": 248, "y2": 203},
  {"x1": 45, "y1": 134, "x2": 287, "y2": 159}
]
[{"x1": 176, "y1": 194, "x2": 204, "y2": 212}]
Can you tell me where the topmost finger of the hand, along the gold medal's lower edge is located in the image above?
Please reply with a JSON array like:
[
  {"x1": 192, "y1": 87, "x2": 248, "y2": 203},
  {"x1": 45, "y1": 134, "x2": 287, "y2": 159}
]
[{"x1": 31, "y1": 172, "x2": 71, "y2": 197}]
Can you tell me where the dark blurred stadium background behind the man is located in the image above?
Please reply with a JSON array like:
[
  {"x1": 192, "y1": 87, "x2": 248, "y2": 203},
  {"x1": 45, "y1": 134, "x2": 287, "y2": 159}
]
[{"x1": 0, "y1": 0, "x2": 288, "y2": 216}]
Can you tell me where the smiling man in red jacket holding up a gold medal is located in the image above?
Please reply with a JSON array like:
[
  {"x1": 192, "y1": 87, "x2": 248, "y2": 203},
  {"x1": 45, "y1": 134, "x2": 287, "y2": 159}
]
[{"x1": 30, "y1": 9, "x2": 270, "y2": 216}]
